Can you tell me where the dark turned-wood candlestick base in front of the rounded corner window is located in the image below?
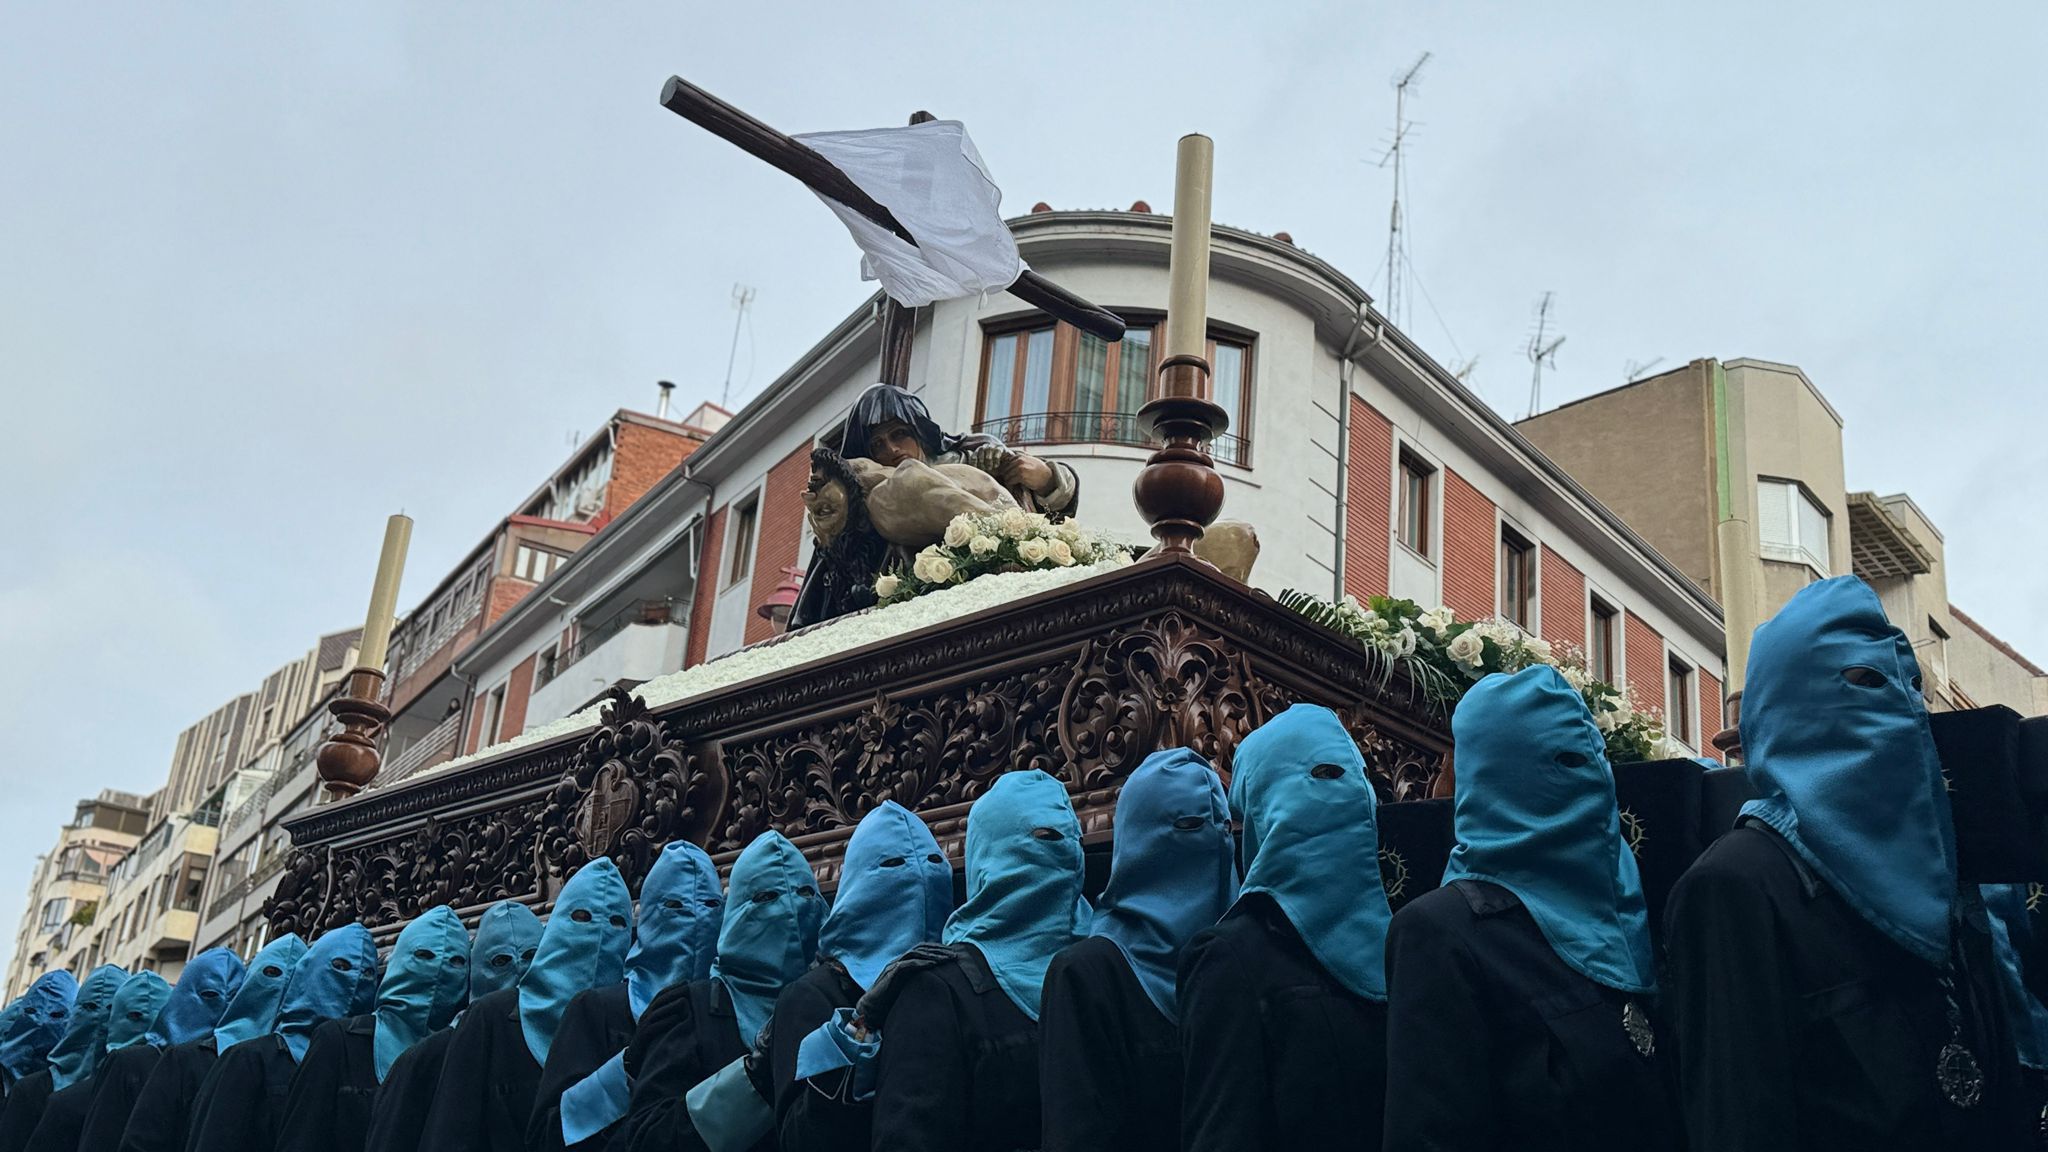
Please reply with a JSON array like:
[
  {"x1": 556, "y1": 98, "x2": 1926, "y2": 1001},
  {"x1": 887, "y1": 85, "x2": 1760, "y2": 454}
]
[{"x1": 1130, "y1": 357, "x2": 1231, "y2": 556}]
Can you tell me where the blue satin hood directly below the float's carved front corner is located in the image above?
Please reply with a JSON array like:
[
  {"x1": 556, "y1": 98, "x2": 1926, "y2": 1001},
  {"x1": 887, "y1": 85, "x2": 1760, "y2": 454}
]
[{"x1": 1090, "y1": 748, "x2": 1237, "y2": 1021}]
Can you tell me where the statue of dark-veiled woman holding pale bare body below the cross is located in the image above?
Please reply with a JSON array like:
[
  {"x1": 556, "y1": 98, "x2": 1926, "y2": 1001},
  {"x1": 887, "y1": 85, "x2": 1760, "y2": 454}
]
[{"x1": 788, "y1": 383, "x2": 1081, "y2": 627}]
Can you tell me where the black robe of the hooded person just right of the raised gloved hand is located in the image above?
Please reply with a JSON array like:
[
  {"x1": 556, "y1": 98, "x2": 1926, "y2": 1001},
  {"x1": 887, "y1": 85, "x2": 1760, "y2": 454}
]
[{"x1": 874, "y1": 947, "x2": 1038, "y2": 1152}]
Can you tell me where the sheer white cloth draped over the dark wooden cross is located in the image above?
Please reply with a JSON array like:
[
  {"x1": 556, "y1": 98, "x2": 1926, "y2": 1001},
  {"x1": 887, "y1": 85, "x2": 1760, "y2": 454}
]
[{"x1": 797, "y1": 121, "x2": 1024, "y2": 307}]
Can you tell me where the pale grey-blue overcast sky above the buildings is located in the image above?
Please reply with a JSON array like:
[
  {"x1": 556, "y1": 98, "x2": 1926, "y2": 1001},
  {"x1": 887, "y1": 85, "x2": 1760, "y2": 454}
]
[{"x1": 0, "y1": 0, "x2": 2048, "y2": 953}]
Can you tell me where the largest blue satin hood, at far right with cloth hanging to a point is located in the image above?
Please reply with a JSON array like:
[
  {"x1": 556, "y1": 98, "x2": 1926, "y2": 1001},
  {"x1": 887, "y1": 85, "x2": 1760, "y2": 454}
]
[{"x1": 1736, "y1": 576, "x2": 1956, "y2": 965}]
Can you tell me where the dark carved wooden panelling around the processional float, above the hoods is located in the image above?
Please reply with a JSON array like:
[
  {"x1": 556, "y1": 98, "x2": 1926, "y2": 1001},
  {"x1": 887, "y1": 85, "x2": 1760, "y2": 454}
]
[{"x1": 268, "y1": 558, "x2": 1450, "y2": 937}]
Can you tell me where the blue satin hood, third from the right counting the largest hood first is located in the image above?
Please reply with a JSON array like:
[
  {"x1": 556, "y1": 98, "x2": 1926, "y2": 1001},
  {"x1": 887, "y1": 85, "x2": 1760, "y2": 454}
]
[{"x1": 1231, "y1": 703, "x2": 1393, "y2": 1000}]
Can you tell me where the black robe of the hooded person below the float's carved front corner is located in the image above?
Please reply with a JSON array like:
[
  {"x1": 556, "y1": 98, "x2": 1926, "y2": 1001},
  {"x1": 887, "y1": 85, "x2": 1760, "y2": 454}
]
[{"x1": 1038, "y1": 937, "x2": 1182, "y2": 1152}]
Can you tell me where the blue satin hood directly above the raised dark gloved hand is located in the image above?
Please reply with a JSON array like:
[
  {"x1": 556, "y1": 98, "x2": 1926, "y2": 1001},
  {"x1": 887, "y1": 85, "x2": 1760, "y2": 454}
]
[{"x1": 817, "y1": 799, "x2": 952, "y2": 988}]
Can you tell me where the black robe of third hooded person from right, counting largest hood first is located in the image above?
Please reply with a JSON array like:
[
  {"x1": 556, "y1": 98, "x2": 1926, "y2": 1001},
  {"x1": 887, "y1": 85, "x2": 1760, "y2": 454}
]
[{"x1": 1180, "y1": 892, "x2": 1386, "y2": 1152}]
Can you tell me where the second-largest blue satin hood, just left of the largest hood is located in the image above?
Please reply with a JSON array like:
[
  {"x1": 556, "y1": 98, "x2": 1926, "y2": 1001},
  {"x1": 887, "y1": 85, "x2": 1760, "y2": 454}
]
[{"x1": 1444, "y1": 664, "x2": 1657, "y2": 992}]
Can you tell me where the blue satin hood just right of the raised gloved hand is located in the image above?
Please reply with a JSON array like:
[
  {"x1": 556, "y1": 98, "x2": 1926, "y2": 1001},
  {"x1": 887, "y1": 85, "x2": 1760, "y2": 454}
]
[{"x1": 944, "y1": 769, "x2": 1090, "y2": 1021}]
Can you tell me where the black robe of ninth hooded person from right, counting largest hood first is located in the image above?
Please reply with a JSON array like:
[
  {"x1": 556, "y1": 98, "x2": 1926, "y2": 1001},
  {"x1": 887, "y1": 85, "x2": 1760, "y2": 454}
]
[{"x1": 420, "y1": 988, "x2": 541, "y2": 1152}]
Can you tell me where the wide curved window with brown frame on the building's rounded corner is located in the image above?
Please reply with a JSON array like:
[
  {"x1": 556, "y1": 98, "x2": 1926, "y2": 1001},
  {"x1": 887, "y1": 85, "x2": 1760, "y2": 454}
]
[{"x1": 975, "y1": 320, "x2": 1253, "y2": 467}]
